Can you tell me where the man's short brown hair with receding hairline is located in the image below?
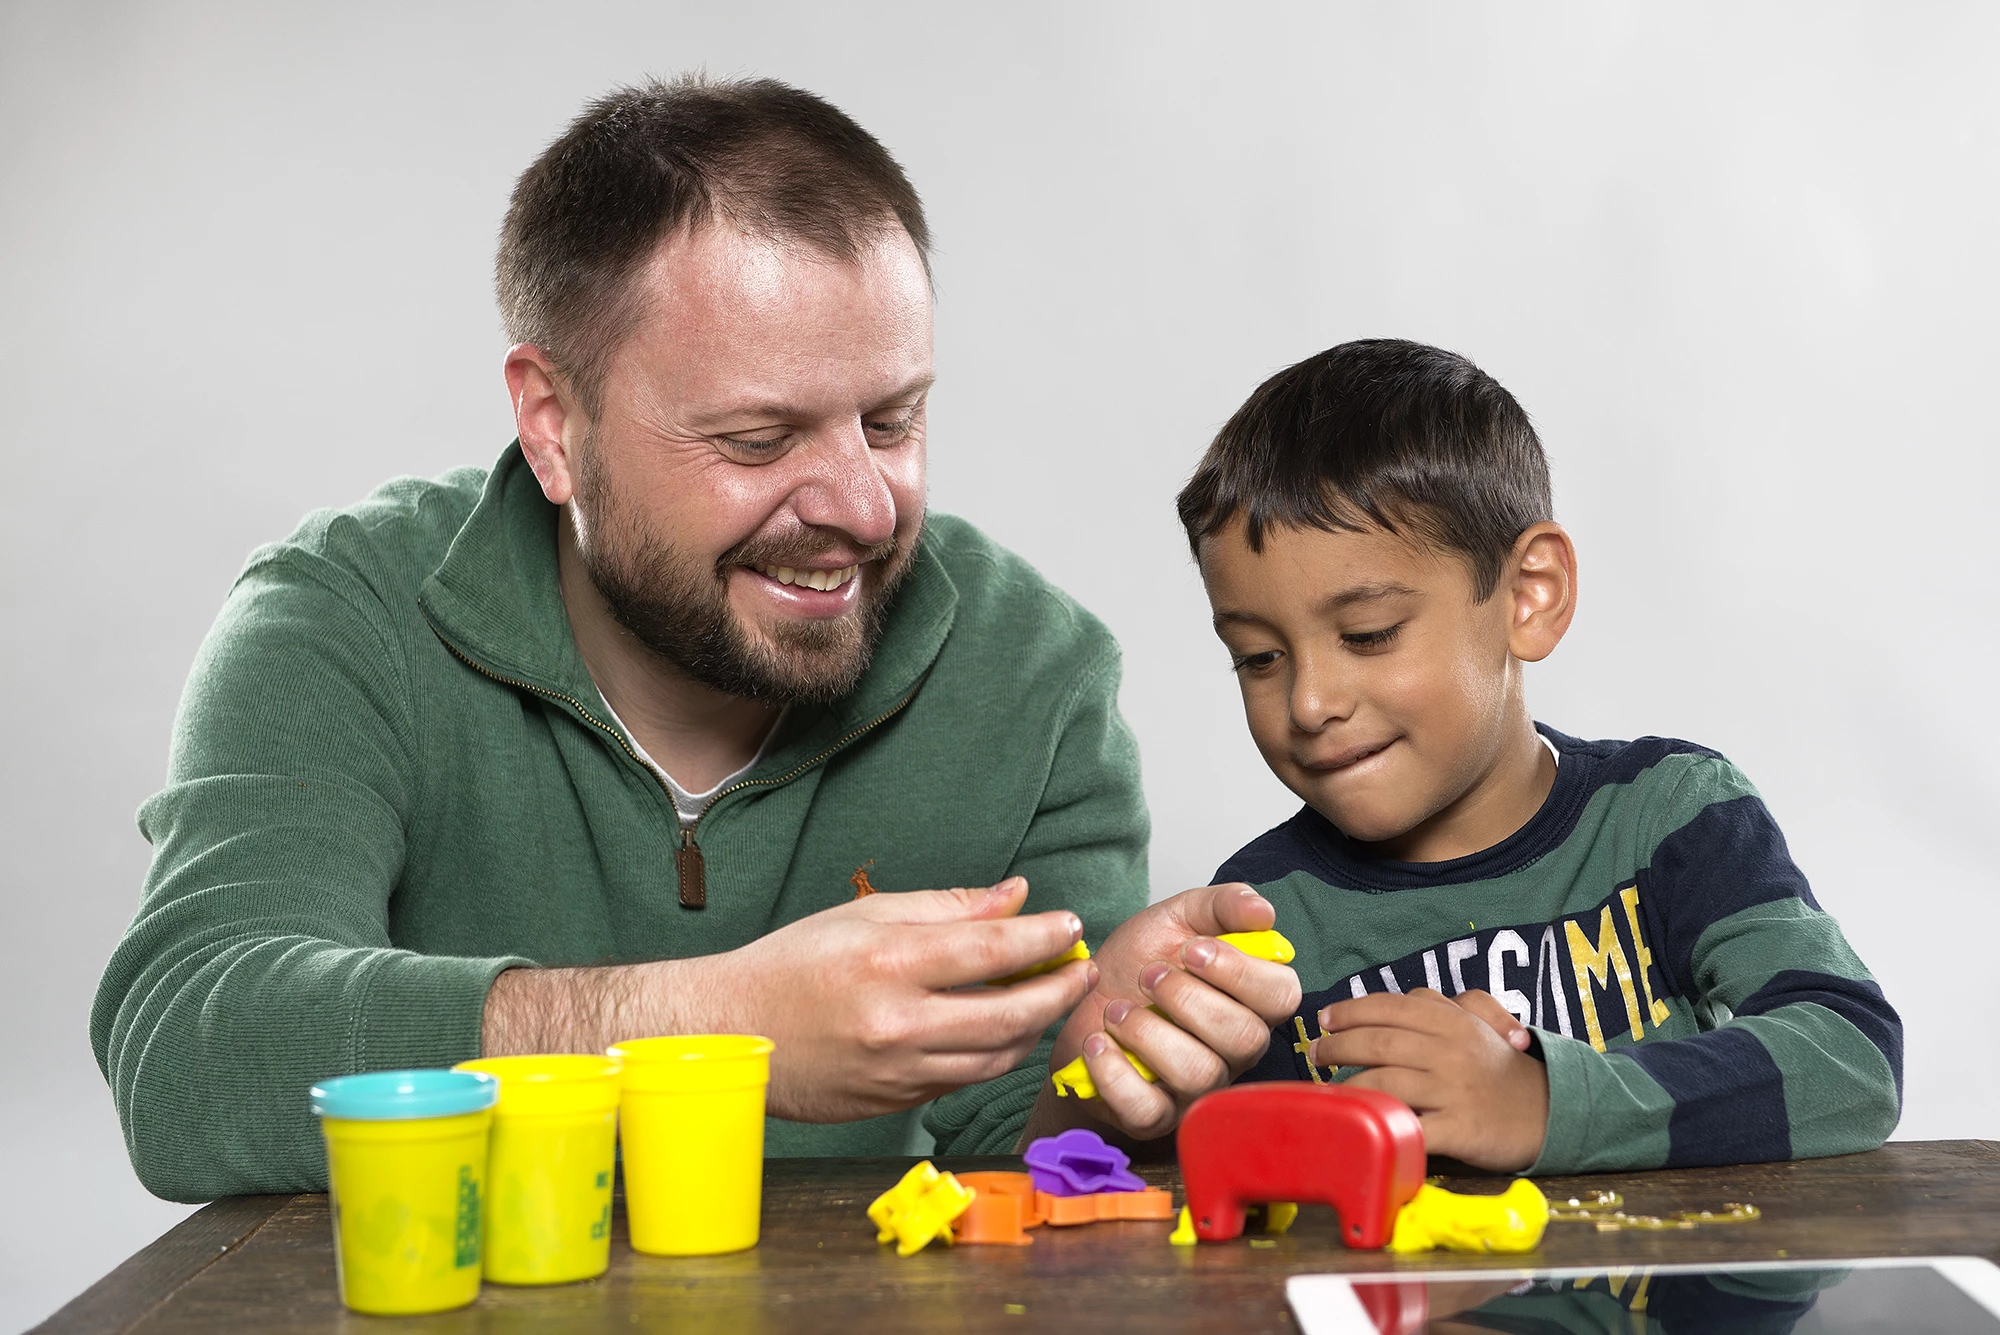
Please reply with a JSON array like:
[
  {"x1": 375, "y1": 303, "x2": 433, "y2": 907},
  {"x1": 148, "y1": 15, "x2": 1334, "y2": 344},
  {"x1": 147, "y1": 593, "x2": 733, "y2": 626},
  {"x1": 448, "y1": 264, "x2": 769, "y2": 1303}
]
[{"x1": 494, "y1": 74, "x2": 930, "y2": 416}]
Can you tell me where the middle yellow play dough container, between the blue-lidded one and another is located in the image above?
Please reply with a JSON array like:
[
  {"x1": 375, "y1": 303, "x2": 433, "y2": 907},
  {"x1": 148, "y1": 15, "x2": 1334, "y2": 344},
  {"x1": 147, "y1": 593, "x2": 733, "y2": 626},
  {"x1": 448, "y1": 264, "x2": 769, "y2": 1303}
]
[{"x1": 452, "y1": 1055, "x2": 618, "y2": 1283}]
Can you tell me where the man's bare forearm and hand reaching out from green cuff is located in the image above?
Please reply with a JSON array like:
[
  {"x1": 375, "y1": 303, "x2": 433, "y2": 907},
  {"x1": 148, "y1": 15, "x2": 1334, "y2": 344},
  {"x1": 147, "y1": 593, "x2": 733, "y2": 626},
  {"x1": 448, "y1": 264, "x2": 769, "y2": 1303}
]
[{"x1": 486, "y1": 877, "x2": 1098, "y2": 1121}]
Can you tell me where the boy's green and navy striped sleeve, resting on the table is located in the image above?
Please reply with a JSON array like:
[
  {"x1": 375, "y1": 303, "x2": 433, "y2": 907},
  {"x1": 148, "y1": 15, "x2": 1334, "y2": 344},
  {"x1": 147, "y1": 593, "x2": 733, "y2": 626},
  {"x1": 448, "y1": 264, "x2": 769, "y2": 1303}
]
[{"x1": 1528, "y1": 759, "x2": 1902, "y2": 1173}]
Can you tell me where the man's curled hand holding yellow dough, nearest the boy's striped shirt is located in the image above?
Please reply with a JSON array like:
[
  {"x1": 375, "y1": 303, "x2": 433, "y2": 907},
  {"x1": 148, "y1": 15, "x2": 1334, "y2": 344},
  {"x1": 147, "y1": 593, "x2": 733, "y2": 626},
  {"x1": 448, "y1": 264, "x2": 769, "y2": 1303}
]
[{"x1": 1030, "y1": 885, "x2": 1298, "y2": 1139}]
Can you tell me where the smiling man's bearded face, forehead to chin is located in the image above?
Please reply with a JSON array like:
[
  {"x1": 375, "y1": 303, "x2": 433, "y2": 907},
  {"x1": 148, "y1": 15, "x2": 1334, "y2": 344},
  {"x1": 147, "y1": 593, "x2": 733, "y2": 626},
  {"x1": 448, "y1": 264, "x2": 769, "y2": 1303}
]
[{"x1": 572, "y1": 226, "x2": 932, "y2": 703}]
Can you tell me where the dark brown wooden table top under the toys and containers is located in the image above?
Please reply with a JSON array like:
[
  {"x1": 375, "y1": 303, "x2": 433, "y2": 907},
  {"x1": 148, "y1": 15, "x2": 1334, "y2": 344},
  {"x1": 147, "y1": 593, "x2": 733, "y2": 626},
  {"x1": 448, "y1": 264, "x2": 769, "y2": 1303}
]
[{"x1": 38, "y1": 1141, "x2": 2000, "y2": 1335}]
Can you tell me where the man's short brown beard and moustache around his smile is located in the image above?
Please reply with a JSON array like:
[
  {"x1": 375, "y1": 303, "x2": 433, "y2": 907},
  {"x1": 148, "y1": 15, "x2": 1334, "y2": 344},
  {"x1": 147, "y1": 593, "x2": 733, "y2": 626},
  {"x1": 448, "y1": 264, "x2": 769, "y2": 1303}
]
[{"x1": 574, "y1": 442, "x2": 918, "y2": 705}]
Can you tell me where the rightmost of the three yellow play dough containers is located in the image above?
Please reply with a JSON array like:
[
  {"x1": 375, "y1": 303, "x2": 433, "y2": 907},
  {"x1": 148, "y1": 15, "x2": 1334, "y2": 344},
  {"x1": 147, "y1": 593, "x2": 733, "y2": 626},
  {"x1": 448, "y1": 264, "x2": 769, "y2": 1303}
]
[{"x1": 610, "y1": 1033, "x2": 772, "y2": 1257}]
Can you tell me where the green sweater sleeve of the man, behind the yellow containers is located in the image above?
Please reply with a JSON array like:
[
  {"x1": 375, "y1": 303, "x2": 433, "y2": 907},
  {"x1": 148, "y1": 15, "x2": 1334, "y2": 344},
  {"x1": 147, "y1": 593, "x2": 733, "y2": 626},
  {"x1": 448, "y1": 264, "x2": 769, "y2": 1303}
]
[{"x1": 90, "y1": 548, "x2": 526, "y2": 1201}]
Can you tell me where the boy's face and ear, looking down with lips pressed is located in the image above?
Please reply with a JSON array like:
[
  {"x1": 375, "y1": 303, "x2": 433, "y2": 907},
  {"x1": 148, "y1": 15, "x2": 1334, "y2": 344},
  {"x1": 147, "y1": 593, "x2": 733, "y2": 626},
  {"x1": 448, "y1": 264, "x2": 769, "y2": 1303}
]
[{"x1": 1202, "y1": 516, "x2": 1574, "y2": 861}]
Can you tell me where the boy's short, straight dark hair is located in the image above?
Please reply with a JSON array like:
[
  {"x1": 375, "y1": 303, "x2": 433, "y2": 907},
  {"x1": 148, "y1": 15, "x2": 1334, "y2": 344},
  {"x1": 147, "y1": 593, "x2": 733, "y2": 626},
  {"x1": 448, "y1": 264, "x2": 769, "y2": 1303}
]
[{"x1": 1176, "y1": 338, "x2": 1554, "y2": 602}]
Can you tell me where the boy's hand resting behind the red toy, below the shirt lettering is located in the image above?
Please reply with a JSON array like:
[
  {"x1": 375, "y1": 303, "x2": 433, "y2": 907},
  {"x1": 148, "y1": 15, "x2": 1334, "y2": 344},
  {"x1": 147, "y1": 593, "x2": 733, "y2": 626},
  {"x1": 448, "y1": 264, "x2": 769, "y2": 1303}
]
[{"x1": 1312, "y1": 987, "x2": 1548, "y2": 1173}]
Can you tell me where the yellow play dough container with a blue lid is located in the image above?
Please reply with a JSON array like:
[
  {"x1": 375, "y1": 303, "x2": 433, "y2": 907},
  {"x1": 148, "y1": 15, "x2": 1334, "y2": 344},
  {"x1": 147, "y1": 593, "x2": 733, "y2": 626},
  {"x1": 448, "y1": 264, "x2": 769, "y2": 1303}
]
[{"x1": 312, "y1": 1071, "x2": 500, "y2": 1315}]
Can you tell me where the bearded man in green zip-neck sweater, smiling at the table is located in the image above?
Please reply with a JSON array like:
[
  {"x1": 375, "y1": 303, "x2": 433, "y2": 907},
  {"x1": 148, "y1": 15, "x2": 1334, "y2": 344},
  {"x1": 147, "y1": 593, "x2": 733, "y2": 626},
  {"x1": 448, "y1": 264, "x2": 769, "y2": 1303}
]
[{"x1": 92, "y1": 80, "x2": 1296, "y2": 1199}]
